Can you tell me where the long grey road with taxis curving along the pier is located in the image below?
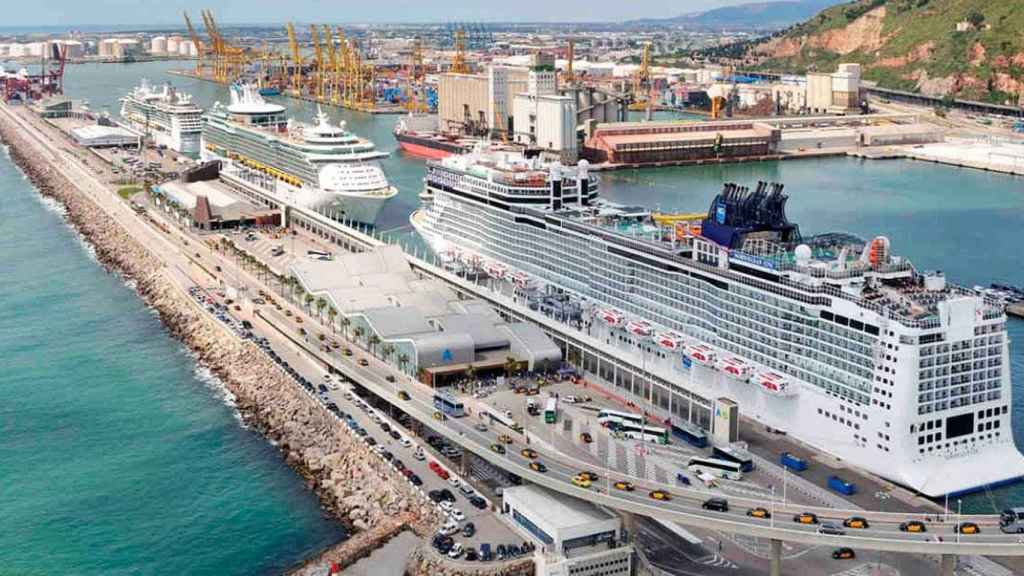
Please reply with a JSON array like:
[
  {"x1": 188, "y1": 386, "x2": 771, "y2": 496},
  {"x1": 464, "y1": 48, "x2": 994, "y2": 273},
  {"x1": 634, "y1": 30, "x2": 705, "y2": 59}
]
[{"x1": 0, "y1": 99, "x2": 1024, "y2": 565}]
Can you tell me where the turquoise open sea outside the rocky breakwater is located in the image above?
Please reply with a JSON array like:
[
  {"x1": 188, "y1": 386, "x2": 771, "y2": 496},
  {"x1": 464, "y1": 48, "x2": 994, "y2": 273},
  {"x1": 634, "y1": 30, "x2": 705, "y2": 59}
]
[{"x1": 0, "y1": 146, "x2": 344, "y2": 576}]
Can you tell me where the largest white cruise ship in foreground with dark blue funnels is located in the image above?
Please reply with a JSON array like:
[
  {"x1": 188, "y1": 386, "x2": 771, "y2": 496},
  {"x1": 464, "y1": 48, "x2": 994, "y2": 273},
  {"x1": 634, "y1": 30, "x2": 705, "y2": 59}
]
[{"x1": 411, "y1": 149, "x2": 1024, "y2": 496}]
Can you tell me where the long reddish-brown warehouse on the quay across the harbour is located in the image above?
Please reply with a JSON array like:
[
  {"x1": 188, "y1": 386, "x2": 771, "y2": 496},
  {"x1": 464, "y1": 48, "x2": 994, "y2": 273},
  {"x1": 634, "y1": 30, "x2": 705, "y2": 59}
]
[{"x1": 583, "y1": 121, "x2": 780, "y2": 165}]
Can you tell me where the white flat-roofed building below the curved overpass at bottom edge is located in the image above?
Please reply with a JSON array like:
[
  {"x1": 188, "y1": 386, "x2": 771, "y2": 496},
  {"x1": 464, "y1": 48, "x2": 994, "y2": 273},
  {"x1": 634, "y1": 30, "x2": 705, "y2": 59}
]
[{"x1": 502, "y1": 485, "x2": 633, "y2": 576}]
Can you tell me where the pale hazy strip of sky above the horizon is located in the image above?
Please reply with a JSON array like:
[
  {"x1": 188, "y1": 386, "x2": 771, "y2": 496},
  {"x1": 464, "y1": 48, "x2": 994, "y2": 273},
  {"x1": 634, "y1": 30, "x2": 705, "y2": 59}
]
[{"x1": 0, "y1": 0, "x2": 774, "y2": 27}]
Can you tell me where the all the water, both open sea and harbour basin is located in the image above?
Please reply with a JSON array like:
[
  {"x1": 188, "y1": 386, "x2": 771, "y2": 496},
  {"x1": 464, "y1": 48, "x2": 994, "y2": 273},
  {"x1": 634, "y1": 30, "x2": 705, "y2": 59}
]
[{"x1": 0, "y1": 63, "x2": 1024, "y2": 575}]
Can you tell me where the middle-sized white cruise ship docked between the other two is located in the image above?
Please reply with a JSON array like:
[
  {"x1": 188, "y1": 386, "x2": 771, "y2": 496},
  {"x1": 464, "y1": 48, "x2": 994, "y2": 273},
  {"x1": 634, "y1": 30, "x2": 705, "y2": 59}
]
[{"x1": 203, "y1": 85, "x2": 397, "y2": 224}]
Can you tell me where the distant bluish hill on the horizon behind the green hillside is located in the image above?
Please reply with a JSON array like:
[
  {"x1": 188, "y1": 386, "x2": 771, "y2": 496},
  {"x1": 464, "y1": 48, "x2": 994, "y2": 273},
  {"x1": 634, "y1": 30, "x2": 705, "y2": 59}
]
[{"x1": 626, "y1": 0, "x2": 844, "y2": 30}]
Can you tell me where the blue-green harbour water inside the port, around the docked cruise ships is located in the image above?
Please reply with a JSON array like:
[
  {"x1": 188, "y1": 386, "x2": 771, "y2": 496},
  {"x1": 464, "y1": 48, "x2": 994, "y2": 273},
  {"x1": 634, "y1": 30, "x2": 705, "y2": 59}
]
[{"x1": 58, "y1": 63, "x2": 1024, "y2": 509}]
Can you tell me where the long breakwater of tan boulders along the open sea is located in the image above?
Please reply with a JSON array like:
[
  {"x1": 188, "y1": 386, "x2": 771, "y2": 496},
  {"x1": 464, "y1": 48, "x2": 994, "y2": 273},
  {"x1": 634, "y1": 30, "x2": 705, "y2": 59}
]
[{"x1": 0, "y1": 109, "x2": 438, "y2": 566}]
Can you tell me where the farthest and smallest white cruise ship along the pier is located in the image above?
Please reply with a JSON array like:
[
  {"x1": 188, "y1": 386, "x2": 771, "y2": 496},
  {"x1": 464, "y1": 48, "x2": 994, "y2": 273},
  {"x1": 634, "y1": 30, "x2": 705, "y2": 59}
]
[{"x1": 121, "y1": 80, "x2": 203, "y2": 157}]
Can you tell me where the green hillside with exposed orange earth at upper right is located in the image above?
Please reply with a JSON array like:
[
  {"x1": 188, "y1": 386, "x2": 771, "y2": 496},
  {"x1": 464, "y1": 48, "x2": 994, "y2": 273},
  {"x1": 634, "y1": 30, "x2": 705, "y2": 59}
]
[{"x1": 750, "y1": 0, "x2": 1024, "y2": 105}]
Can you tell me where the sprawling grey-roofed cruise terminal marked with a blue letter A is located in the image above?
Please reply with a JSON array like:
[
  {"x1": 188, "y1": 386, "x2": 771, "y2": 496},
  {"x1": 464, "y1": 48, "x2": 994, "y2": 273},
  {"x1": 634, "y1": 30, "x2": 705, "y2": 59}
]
[{"x1": 290, "y1": 246, "x2": 562, "y2": 385}]
